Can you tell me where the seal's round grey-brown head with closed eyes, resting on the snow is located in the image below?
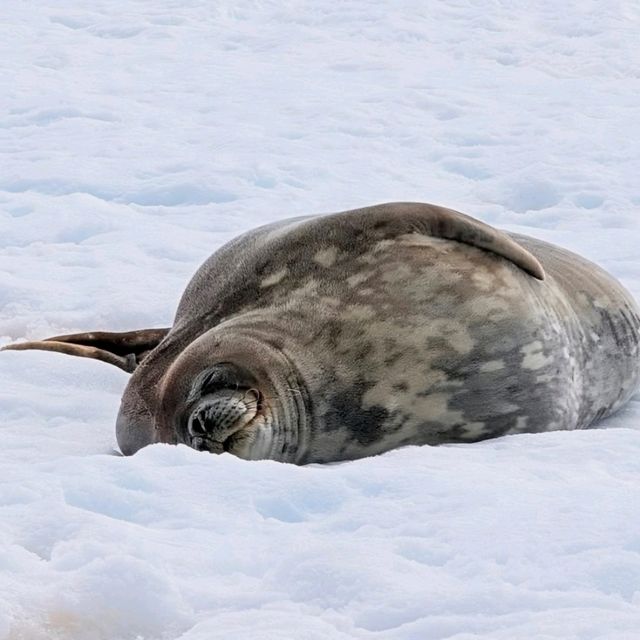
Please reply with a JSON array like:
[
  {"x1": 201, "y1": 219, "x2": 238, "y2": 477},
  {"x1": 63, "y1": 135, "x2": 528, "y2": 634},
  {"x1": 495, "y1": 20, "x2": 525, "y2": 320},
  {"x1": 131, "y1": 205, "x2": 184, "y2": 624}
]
[{"x1": 150, "y1": 324, "x2": 307, "y2": 460}]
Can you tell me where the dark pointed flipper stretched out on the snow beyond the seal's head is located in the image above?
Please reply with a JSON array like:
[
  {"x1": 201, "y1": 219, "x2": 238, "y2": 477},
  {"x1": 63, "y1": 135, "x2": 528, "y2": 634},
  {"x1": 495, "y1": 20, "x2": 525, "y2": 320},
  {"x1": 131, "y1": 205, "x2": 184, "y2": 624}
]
[{"x1": 0, "y1": 328, "x2": 169, "y2": 373}]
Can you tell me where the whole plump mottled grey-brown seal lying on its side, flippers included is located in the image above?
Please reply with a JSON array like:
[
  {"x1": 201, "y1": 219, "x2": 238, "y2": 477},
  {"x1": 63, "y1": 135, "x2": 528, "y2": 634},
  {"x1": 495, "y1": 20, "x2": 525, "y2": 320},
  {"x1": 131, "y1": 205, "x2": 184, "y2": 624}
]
[{"x1": 5, "y1": 203, "x2": 640, "y2": 464}]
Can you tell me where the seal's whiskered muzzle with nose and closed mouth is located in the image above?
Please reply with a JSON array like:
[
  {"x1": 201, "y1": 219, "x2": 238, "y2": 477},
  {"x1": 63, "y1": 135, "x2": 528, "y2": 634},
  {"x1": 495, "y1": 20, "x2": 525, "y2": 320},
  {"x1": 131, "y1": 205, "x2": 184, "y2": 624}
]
[{"x1": 187, "y1": 389, "x2": 263, "y2": 453}]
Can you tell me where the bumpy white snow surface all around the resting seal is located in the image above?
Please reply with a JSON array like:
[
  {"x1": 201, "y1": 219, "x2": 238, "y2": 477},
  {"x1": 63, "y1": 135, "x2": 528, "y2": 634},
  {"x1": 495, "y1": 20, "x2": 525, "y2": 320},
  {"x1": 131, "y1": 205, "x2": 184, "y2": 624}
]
[{"x1": 0, "y1": 0, "x2": 640, "y2": 640}]
